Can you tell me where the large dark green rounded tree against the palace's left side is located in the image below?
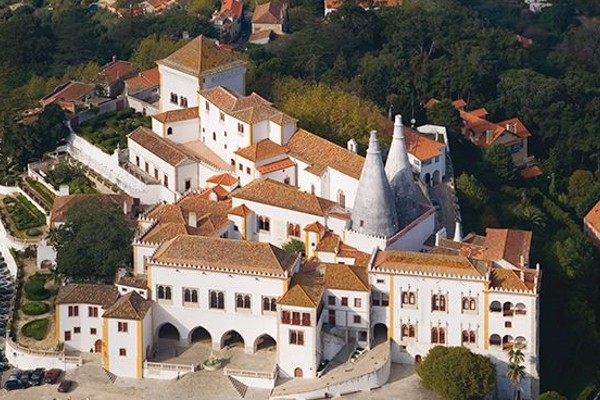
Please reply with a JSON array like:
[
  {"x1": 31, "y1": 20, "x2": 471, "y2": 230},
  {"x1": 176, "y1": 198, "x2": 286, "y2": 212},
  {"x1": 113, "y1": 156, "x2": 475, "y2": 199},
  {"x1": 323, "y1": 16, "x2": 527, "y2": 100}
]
[{"x1": 54, "y1": 196, "x2": 133, "y2": 282}]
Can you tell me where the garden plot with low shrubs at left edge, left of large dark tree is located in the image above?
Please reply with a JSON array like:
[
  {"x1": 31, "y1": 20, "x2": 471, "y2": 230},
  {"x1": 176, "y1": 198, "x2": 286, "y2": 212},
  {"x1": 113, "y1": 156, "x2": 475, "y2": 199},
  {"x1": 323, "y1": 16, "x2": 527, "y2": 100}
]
[{"x1": 0, "y1": 194, "x2": 46, "y2": 238}]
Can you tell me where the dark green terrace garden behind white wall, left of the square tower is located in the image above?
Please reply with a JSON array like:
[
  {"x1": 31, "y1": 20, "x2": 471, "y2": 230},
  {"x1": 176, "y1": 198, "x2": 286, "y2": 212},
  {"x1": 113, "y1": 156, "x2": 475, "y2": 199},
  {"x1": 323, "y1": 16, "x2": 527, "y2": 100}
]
[{"x1": 76, "y1": 109, "x2": 152, "y2": 154}]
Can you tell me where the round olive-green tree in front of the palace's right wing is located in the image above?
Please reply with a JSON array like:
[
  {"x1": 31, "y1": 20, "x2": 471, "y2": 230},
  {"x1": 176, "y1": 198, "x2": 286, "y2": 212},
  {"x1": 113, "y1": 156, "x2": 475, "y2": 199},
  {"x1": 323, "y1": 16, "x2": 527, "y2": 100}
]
[{"x1": 417, "y1": 346, "x2": 496, "y2": 400}]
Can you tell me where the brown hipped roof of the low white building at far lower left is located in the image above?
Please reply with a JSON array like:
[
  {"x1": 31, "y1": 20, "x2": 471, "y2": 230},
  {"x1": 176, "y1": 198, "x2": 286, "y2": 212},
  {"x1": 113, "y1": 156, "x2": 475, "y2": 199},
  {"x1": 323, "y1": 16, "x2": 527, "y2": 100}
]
[{"x1": 54, "y1": 283, "x2": 119, "y2": 307}]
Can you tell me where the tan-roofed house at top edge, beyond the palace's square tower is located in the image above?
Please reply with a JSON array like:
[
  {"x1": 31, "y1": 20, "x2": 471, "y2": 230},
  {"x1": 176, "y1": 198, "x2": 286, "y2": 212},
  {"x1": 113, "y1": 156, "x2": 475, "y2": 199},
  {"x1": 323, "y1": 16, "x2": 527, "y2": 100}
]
[{"x1": 249, "y1": 1, "x2": 287, "y2": 44}]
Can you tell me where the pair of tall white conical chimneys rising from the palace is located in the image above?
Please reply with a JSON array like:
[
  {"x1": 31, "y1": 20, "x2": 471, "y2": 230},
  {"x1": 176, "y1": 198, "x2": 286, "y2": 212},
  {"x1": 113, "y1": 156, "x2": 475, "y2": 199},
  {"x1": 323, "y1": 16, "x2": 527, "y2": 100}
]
[{"x1": 352, "y1": 115, "x2": 419, "y2": 237}]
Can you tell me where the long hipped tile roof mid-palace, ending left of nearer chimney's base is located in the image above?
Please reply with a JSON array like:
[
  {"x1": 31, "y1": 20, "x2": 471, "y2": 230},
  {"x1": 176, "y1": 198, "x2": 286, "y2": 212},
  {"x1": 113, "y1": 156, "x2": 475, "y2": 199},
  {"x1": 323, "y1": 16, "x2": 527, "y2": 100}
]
[{"x1": 231, "y1": 178, "x2": 338, "y2": 217}]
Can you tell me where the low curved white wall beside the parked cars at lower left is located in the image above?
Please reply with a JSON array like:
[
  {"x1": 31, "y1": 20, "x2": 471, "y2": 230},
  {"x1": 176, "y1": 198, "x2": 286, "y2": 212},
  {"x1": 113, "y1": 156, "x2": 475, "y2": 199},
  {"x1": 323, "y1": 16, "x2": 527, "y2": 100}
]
[{"x1": 6, "y1": 339, "x2": 82, "y2": 370}]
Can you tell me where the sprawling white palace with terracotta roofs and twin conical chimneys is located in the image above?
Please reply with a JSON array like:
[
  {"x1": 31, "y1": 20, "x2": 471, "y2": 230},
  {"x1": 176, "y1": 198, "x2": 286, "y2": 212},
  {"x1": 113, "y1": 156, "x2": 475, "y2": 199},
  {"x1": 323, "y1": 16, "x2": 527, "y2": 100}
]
[{"x1": 56, "y1": 36, "x2": 541, "y2": 398}]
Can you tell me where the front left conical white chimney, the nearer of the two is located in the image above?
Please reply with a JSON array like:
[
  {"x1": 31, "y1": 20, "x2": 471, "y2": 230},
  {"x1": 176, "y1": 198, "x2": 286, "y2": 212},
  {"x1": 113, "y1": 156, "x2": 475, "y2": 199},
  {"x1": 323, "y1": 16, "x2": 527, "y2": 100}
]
[{"x1": 352, "y1": 131, "x2": 399, "y2": 237}]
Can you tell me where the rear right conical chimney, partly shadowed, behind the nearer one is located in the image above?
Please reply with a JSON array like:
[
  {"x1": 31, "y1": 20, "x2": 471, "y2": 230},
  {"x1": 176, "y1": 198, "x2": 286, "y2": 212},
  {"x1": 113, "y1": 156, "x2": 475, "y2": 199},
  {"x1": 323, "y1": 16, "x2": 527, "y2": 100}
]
[{"x1": 385, "y1": 115, "x2": 421, "y2": 228}]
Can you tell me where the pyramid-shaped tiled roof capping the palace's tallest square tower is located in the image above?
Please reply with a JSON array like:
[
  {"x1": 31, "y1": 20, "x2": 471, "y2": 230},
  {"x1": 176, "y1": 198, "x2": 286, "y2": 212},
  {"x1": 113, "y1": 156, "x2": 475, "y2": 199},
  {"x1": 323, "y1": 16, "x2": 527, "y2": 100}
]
[{"x1": 157, "y1": 35, "x2": 244, "y2": 76}]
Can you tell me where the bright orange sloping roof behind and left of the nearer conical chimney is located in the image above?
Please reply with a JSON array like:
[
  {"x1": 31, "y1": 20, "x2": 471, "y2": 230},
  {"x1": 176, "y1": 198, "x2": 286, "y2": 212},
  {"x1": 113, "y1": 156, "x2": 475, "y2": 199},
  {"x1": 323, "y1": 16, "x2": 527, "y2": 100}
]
[{"x1": 286, "y1": 129, "x2": 365, "y2": 179}]
